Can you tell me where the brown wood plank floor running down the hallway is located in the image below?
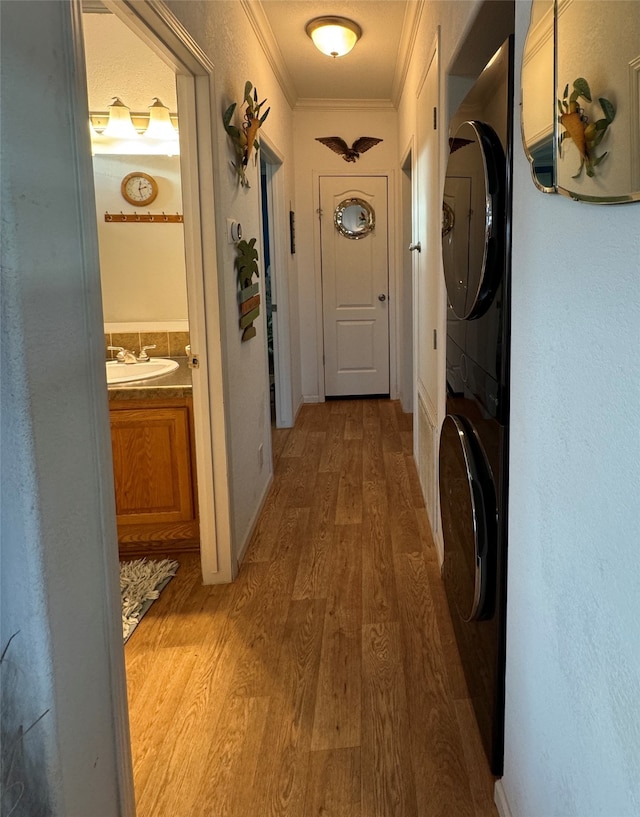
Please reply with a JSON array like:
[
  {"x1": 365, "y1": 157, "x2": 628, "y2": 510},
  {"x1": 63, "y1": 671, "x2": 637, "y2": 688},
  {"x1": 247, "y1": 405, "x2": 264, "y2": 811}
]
[{"x1": 125, "y1": 400, "x2": 497, "y2": 817}]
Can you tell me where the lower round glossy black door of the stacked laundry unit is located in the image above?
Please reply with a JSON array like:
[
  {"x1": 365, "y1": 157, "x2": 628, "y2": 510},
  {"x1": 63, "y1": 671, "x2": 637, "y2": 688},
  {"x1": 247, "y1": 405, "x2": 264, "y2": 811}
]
[{"x1": 440, "y1": 414, "x2": 498, "y2": 622}]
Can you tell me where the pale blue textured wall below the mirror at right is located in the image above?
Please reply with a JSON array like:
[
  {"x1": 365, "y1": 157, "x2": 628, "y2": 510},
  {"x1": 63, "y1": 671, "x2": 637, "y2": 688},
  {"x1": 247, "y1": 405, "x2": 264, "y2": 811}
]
[{"x1": 502, "y1": 2, "x2": 640, "y2": 817}]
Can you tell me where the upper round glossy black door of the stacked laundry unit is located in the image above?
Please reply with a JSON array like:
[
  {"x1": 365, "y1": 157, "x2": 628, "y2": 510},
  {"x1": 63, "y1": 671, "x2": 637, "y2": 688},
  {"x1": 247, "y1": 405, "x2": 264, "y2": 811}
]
[{"x1": 442, "y1": 121, "x2": 506, "y2": 320}]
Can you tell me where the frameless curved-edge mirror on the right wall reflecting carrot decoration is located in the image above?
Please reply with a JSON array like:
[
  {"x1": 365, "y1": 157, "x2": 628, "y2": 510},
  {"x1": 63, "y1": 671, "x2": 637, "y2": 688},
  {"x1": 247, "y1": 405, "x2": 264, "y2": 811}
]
[{"x1": 521, "y1": 0, "x2": 640, "y2": 204}]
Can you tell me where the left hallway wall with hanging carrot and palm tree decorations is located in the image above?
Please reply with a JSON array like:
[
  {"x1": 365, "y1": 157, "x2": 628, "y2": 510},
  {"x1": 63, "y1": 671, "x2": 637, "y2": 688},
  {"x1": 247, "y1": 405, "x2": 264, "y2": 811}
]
[{"x1": 162, "y1": 0, "x2": 300, "y2": 559}]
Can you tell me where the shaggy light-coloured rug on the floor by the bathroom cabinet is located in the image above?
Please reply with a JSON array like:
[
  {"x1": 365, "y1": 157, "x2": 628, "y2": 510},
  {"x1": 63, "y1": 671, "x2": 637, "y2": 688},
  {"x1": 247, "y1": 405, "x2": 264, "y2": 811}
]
[{"x1": 120, "y1": 559, "x2": 179, "y2": 644}]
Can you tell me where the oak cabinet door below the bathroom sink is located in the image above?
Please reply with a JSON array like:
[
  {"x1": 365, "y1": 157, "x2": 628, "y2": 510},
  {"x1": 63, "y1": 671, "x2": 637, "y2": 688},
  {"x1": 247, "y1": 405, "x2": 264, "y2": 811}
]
[{"x1": 111, "y1": 406, "x2": 196, "y2": 532}]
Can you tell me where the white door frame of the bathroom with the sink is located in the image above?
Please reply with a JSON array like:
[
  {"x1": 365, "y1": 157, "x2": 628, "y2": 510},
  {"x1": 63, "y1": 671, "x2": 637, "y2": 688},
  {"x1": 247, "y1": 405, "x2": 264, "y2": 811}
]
[{"x1": 97, "y1": 0, "x2": 233, "y2": 584}]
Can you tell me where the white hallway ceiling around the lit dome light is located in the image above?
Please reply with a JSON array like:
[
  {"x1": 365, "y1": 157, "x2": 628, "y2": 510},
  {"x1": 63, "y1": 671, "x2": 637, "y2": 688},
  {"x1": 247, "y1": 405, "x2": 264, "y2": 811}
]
[{"x1": 249, "y1": 0, "x2": 410, "y2": 104}]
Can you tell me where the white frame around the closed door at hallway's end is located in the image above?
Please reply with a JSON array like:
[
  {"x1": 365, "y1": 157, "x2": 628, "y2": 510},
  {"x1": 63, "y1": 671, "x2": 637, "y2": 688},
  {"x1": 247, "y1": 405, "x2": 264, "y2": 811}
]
[{"x1": 312, "y1": 170, "x2": 398, "y2": 403}]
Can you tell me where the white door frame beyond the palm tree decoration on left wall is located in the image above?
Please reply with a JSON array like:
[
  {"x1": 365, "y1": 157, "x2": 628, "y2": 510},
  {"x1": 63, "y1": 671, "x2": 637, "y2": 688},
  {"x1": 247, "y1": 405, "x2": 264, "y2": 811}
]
[{"x1": 260, "y1": 134, "x2": 294, "y2": 428}]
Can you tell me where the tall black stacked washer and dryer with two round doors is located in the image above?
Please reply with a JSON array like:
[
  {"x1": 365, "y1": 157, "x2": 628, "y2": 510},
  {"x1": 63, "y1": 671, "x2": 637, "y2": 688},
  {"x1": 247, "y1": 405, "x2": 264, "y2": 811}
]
[{"x1": 440, "y1": 40, "x2": 513, "y2": 775}]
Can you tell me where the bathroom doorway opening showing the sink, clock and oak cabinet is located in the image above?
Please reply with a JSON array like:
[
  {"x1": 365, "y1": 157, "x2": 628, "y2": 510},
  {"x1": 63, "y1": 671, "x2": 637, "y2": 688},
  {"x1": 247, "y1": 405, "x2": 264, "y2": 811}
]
[{"x1": 83, "y1": 12, "x2": 200, "y2": 557}]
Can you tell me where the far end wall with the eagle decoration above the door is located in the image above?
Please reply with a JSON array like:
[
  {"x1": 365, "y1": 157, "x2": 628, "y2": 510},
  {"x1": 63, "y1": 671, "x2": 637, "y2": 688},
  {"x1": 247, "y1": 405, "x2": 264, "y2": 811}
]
[{"x1": 294, "y1": 105, "x2": 401, "y2": 402}]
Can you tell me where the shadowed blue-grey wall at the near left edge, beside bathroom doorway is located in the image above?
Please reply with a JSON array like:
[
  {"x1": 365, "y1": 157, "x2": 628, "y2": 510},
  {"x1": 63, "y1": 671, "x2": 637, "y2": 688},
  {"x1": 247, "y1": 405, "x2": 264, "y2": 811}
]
[{"x1": 0, "y1": 2, "x2": 134, "y2": 817}]
